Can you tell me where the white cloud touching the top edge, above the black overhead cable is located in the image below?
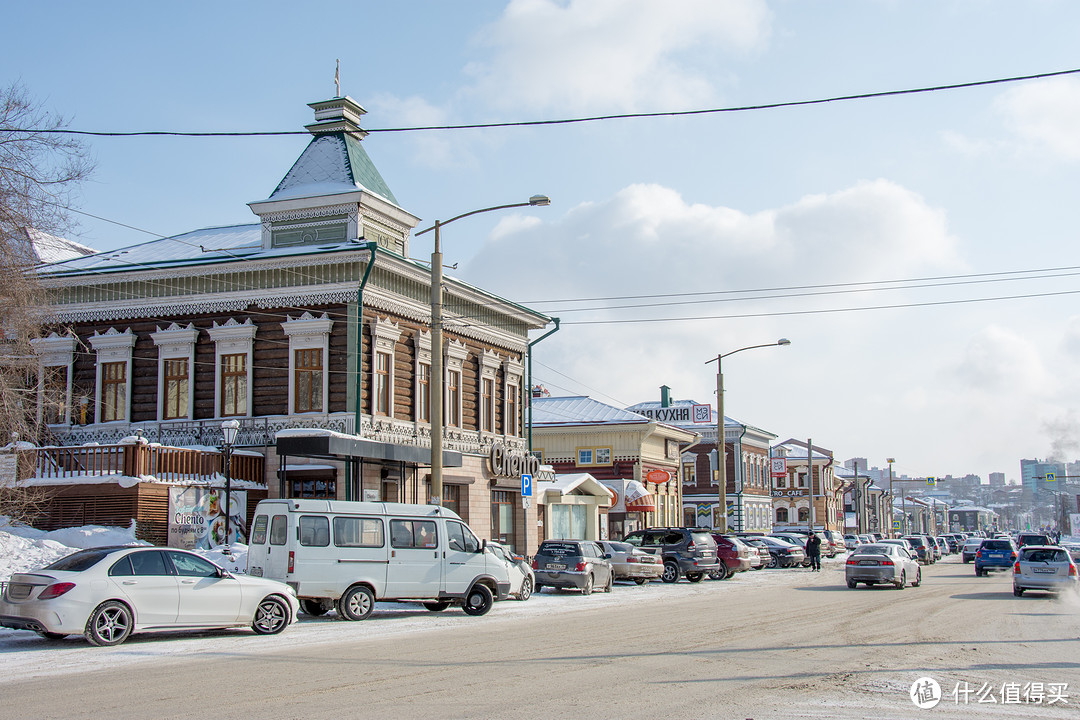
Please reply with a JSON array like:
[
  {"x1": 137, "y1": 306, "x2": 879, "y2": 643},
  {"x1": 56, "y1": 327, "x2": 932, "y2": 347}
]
[{"x1": 468, "y1": 0, "x2": 771, "y2": 113}]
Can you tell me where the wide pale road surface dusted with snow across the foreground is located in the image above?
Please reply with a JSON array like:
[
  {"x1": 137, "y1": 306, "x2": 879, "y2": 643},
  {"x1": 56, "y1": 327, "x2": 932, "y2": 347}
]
[{"x1": 0, "y1": 558, "x2": 1080, "y2": 720}]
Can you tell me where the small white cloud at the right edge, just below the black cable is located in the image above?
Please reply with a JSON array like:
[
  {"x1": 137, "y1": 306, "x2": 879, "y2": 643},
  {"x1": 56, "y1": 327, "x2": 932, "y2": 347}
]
[{"x1": 995, "y1": 77, "x2": 1080, "y2": 161}]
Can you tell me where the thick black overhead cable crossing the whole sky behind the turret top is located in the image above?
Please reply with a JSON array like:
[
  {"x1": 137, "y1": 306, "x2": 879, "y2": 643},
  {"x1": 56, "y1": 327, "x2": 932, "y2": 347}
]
[{"x1": 0, "y1": 68, "x2": 1080, "y2": 137}]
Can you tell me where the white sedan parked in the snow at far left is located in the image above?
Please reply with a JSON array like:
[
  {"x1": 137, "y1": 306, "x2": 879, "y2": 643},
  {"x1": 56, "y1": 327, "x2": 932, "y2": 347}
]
[{"x1": 0, "y1": 546, "x2": 299, "y2": 646}]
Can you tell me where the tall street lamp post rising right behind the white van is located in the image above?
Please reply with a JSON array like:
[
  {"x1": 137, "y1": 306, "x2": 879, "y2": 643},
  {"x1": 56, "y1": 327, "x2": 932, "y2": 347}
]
[{"x1": 416, "y1": 195, "x2": 551, "y2": 505}]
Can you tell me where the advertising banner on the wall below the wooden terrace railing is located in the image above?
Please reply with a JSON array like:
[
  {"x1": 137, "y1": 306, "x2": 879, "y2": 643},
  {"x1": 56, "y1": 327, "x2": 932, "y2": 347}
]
[{"x1": 168, "y1": 487, "x2": 247, "y2": 549}]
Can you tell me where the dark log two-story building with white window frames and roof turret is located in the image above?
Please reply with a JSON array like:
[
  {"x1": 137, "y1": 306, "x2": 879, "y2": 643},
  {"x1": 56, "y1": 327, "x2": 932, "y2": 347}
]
[{"x1": 37, "y1": 97, "x2": 549, "y2": 552}]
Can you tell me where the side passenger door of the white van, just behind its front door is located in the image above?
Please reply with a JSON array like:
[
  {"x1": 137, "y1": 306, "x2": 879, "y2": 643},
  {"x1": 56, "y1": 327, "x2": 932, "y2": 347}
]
[{"x1": 386, "y1": 518, "x2": 443, "y2": 598}]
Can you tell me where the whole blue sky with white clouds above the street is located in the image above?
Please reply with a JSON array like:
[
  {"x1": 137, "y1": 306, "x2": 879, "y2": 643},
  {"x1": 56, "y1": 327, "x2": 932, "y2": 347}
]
[{"x1": 6, "y1": 0, "x2": 1080, "y2": 480}]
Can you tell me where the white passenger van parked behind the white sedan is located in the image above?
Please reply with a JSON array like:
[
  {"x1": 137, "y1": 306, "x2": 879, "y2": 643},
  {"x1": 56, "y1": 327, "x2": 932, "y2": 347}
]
[{"x1": 247, "y1": 499, "x2": 510, "y2": 620}]
